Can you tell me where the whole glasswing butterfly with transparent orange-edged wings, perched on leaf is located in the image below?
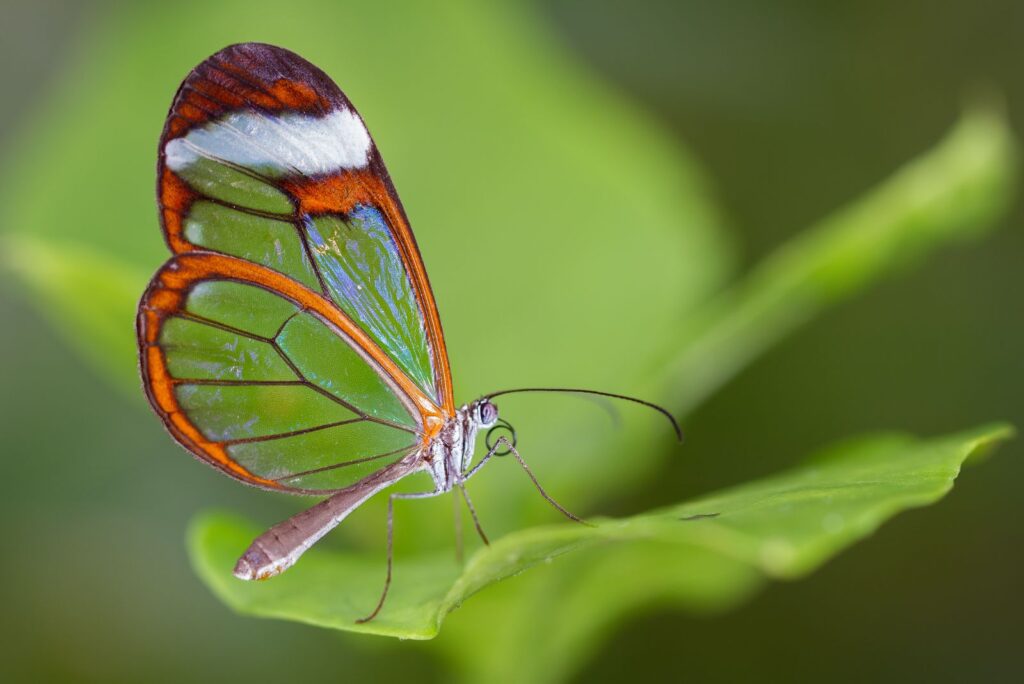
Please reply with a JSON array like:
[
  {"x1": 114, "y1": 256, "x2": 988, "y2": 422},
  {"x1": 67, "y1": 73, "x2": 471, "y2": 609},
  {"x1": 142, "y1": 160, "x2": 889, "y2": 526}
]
[{"x1": 136, "y1": 43, "x2": 679, "y2": 622}]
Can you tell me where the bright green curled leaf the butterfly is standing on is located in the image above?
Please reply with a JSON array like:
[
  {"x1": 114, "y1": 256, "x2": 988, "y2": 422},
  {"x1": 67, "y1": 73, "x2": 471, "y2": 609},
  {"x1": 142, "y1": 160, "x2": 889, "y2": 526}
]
[{"x1": 188, "y1": 425, "x2": 1012, "y2": 651}]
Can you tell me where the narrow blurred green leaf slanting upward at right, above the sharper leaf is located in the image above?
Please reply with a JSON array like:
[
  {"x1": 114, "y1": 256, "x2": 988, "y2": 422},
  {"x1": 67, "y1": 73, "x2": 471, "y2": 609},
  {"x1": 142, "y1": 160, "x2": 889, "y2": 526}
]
[{"x1": 657, "y1": 106, "x2": 1017, "y2": 414}]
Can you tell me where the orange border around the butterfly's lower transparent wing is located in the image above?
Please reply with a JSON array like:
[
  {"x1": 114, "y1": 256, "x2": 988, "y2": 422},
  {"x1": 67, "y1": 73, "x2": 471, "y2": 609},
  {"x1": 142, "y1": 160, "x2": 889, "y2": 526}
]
[{"x1": 136, "y1": 252, "x2": 445, "y2": 494}]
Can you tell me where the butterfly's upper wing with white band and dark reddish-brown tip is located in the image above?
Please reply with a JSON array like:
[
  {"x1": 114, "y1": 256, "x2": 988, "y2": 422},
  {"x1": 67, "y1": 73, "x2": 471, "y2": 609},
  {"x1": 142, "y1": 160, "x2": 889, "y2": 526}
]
[{"x1": 158, "y1": 43, "x2": 454, "y2": 416}]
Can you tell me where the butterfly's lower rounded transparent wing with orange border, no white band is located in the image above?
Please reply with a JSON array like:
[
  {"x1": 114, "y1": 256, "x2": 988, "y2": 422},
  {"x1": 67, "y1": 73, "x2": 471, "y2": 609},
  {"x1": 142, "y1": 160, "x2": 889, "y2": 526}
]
[{"x1": 137, "y1": 253, "x2": 423, "y2": 494}]
